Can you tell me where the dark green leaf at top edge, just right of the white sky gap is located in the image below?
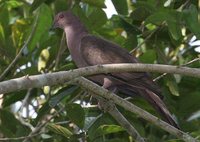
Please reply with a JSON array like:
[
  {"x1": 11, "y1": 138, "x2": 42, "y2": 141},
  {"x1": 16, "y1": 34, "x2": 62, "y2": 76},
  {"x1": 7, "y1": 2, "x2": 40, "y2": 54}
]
[{"x1": 112, "y1": 0, "x2": 128, "y2": 15}]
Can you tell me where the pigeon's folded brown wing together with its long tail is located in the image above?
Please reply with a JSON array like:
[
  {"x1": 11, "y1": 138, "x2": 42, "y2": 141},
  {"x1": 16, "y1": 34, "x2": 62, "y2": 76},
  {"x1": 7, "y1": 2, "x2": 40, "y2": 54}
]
[{"x1": 80, "y1": 35, "x2": 178, "y2": 128}]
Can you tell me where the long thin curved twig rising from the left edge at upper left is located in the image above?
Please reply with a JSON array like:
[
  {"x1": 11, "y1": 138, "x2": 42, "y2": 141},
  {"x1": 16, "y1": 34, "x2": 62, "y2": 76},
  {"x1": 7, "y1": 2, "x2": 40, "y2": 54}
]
[{"x1": 0, "y1": 11, "x2": 39, "y2": 81}]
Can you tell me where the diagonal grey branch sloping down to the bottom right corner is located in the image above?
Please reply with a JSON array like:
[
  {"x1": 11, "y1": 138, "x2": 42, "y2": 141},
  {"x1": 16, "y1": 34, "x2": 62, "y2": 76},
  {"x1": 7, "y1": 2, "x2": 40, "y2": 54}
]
[{"x1": 75, "y1": 77, "x2": 199, "y2": 142}]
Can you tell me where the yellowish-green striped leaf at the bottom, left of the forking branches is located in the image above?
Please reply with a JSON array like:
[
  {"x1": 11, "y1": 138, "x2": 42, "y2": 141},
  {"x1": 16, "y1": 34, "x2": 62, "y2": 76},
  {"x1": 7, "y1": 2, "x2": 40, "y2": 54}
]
[{"x1": 47, "y1": 123, "x2": 73, "y2": 138}]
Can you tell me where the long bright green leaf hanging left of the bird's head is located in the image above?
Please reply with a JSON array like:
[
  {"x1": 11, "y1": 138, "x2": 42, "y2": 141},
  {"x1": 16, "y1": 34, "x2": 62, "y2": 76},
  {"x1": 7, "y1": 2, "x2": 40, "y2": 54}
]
[{"x1": 28, "y1": 4, "x2": 52, "y2": 50}]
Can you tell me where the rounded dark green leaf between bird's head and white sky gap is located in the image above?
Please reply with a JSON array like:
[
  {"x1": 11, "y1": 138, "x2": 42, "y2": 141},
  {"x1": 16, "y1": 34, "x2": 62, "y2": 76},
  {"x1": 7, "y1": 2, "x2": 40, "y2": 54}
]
[{"x1": 88, "y1": 8, "x2": 107, "y2": 29}]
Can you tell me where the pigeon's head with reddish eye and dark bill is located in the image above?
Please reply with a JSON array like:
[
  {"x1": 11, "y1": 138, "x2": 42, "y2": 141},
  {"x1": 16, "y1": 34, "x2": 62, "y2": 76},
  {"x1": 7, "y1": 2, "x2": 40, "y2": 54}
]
[{"x1": 52, "y1": 11, "x2": 76, "y2": 29}]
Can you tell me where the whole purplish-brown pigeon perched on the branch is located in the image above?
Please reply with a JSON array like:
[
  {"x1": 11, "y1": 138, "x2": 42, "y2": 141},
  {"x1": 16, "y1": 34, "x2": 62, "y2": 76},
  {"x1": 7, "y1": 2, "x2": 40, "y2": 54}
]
[{"x1": 53, "y1": 11, "x2": 178, "y2": 127}]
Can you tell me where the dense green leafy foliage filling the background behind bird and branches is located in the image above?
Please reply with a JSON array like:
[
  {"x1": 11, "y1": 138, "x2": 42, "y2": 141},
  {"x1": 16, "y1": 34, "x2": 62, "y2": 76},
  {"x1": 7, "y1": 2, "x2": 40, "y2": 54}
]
[{"x1": 0, "y1": 0, "x2": 200, "y2": 142}]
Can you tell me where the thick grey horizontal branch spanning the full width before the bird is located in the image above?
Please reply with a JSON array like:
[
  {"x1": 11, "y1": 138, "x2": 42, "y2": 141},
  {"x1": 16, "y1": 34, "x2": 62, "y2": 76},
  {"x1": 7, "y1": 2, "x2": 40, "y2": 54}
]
[{"x1": 0, "y1": 63, "x2": 200, "y2": 94}]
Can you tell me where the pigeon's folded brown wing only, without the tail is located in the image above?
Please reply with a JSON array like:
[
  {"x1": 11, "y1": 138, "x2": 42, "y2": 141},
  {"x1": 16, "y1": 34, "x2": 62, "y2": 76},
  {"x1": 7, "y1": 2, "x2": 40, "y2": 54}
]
[{"x1": 80, "y1": 35, "x2": 160, "y2": 95}]
